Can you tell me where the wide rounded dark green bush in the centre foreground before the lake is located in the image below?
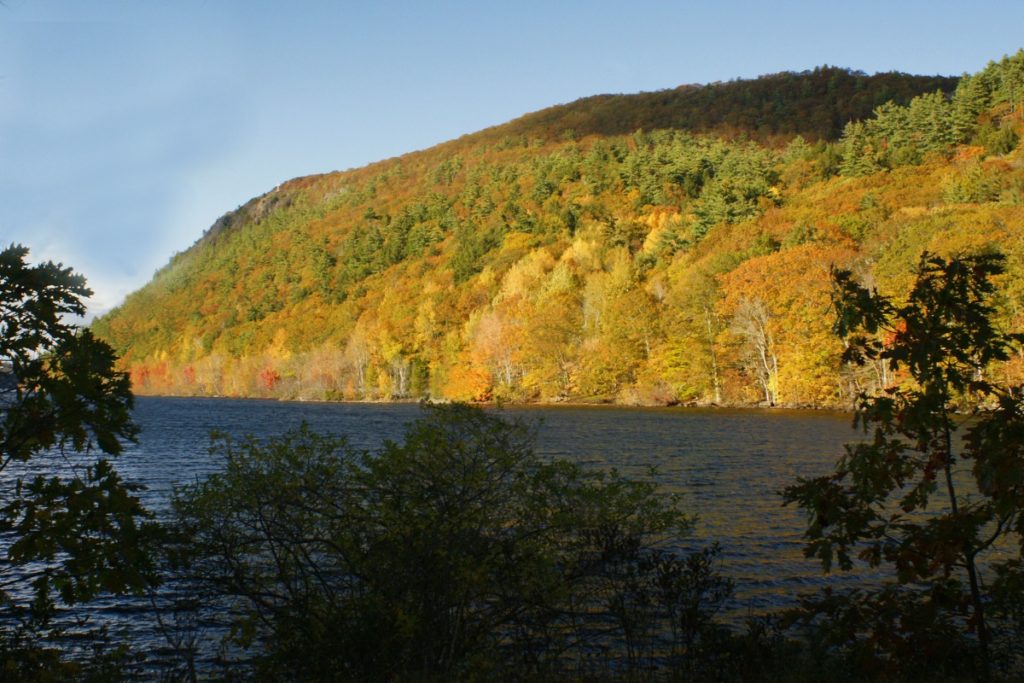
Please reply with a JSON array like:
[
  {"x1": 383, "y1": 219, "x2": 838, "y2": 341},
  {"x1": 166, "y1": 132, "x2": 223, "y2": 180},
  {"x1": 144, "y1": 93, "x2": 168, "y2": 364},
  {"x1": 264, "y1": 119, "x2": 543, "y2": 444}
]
[{"x1": 175, "y1": 404, "x2": 731, "y2": 680}]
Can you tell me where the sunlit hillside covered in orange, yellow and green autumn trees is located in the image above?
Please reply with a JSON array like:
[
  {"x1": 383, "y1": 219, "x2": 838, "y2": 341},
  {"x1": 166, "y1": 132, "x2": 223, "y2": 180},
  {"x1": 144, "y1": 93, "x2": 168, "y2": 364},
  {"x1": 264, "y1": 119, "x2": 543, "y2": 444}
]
[{"x1": 93, "y1": 57, "x2": 1024, "y2": 405}]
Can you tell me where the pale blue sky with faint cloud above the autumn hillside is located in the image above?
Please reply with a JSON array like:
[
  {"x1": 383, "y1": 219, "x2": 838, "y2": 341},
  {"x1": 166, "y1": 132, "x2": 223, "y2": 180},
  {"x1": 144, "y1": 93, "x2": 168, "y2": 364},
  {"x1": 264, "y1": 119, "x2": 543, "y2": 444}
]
[{"x1": 0, "y1": 0, "x2": 1024, "y2": 313}]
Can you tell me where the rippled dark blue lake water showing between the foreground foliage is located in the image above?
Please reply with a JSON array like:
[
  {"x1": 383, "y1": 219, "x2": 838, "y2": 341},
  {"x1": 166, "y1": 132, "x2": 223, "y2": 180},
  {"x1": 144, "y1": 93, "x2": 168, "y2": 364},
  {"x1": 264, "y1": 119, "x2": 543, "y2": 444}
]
[{"x1": 4, "y1": 397, "x2": 858, "y2": 671}]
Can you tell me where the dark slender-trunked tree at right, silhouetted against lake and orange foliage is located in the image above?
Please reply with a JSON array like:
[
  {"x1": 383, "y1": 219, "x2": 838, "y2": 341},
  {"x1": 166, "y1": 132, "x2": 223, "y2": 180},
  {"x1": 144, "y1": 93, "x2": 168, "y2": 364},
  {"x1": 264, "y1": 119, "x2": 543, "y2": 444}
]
[{"x1": 784, "y1": 254, "x2": 1024, "y2": 678}]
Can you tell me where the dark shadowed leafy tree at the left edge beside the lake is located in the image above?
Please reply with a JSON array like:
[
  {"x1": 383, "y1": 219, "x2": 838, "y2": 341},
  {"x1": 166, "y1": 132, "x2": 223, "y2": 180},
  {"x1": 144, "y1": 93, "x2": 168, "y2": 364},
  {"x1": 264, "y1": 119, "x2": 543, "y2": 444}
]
[{"x1": 0, "y1": 246, "x2": 155, "y2": 675}]
